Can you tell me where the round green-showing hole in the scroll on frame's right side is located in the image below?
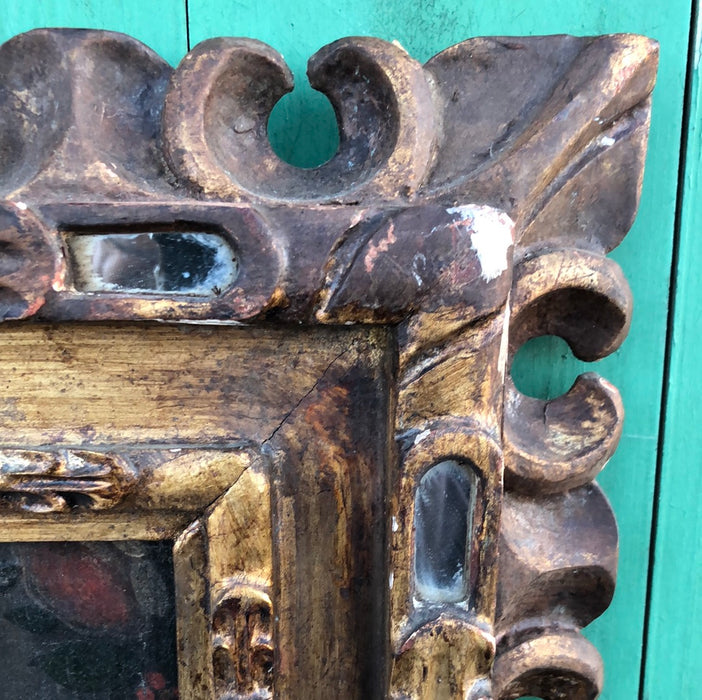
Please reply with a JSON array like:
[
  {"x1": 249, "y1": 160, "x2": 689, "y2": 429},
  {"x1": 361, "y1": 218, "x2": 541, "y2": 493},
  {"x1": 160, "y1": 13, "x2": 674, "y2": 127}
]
[{"x1": 511, "y1": 335, "x2": 589, "y2": 400}]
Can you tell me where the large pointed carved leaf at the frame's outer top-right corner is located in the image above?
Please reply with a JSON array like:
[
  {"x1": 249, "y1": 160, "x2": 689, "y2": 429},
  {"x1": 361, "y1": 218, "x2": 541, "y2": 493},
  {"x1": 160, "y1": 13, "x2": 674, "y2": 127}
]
[{"x1": 426, "y1": 34, "x2": 658, "y2": 252}]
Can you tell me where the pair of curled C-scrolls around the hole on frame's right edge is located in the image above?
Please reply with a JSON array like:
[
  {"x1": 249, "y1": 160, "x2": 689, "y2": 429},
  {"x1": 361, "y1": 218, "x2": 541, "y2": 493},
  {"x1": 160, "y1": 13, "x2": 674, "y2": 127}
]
[{"x1": 505, "y1": 249, "x2": 632, "y2": 493}]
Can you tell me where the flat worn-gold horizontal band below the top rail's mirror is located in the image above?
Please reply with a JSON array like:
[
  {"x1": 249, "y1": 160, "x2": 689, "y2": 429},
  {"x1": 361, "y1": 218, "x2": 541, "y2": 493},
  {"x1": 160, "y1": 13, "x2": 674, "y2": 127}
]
[{"x1": 0, "y1": 325, "x2": 382, "y2": 447}]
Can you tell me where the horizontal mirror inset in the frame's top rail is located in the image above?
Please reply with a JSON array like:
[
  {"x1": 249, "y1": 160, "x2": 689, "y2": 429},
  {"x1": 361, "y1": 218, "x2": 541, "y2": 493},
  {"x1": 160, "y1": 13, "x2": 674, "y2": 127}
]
[{"x1": 66, "y1": 232, "x2": 239, "y2": 296}]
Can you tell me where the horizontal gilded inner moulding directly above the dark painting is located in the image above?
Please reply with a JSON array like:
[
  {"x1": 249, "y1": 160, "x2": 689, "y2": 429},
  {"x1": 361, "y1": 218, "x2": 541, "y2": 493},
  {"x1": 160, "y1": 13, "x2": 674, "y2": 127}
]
[{"x1": 0, "y1": 445, "x2": 264, "y2": 542}]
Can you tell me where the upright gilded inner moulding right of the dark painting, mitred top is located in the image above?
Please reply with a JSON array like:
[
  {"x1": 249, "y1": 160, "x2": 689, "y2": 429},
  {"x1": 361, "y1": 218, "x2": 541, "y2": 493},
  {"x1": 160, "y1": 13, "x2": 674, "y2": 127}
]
[{"x1": 174, "y1": 463, "x2": 274, "y2": 700}]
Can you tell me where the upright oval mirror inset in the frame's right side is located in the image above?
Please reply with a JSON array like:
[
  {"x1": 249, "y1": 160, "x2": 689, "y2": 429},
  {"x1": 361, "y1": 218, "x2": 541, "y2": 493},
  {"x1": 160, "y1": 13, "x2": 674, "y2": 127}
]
[{"x1": 414, "y1": 460, "x2": 477, "y2": 603}]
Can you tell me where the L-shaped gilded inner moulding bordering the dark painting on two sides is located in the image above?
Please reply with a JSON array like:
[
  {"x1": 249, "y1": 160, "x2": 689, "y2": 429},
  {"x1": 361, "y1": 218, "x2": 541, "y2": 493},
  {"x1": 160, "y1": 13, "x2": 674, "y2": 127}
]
[{"x1": 0, "y1": 447, "x2": 273, "y2": 700}]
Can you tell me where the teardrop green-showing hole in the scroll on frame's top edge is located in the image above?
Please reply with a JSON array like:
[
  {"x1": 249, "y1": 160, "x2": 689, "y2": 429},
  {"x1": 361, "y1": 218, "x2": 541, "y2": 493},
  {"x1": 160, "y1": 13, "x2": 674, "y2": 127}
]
[{"x1": 268, "y1": 79, "x2": 339, "y2": 168}]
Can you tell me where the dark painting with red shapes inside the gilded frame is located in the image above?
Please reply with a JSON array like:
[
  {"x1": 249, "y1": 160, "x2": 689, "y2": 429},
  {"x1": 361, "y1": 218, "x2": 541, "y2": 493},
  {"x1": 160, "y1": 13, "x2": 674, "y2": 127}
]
[{"x1": 0, "y1": 541, "x2": 178, "y2": 700}]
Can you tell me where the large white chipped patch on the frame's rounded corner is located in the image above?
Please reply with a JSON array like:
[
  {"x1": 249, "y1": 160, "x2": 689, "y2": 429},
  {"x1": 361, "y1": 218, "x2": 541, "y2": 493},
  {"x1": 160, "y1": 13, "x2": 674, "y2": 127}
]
[{"x1": 446, "y1": 206, "x2": 514, "y2": 282}]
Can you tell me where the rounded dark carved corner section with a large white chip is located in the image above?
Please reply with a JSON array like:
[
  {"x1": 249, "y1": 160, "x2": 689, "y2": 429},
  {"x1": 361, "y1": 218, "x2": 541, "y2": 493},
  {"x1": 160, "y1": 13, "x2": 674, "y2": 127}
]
[{"x1": 316, "y1": 205, "x2": 513, "y2": 323}]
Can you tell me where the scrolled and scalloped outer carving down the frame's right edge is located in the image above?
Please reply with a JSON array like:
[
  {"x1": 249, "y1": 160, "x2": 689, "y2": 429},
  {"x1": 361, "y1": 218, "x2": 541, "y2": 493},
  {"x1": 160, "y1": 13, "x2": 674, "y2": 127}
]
[{"x1": 494, "y1": 248, "x2": 632, "y2": 700}]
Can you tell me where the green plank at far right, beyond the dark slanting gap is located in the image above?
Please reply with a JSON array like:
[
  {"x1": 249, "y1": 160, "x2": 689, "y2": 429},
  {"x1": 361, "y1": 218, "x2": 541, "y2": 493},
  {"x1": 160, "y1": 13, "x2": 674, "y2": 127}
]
[{"x1": 644, "y1": 7, "x2": 702, "y2": 700}]
